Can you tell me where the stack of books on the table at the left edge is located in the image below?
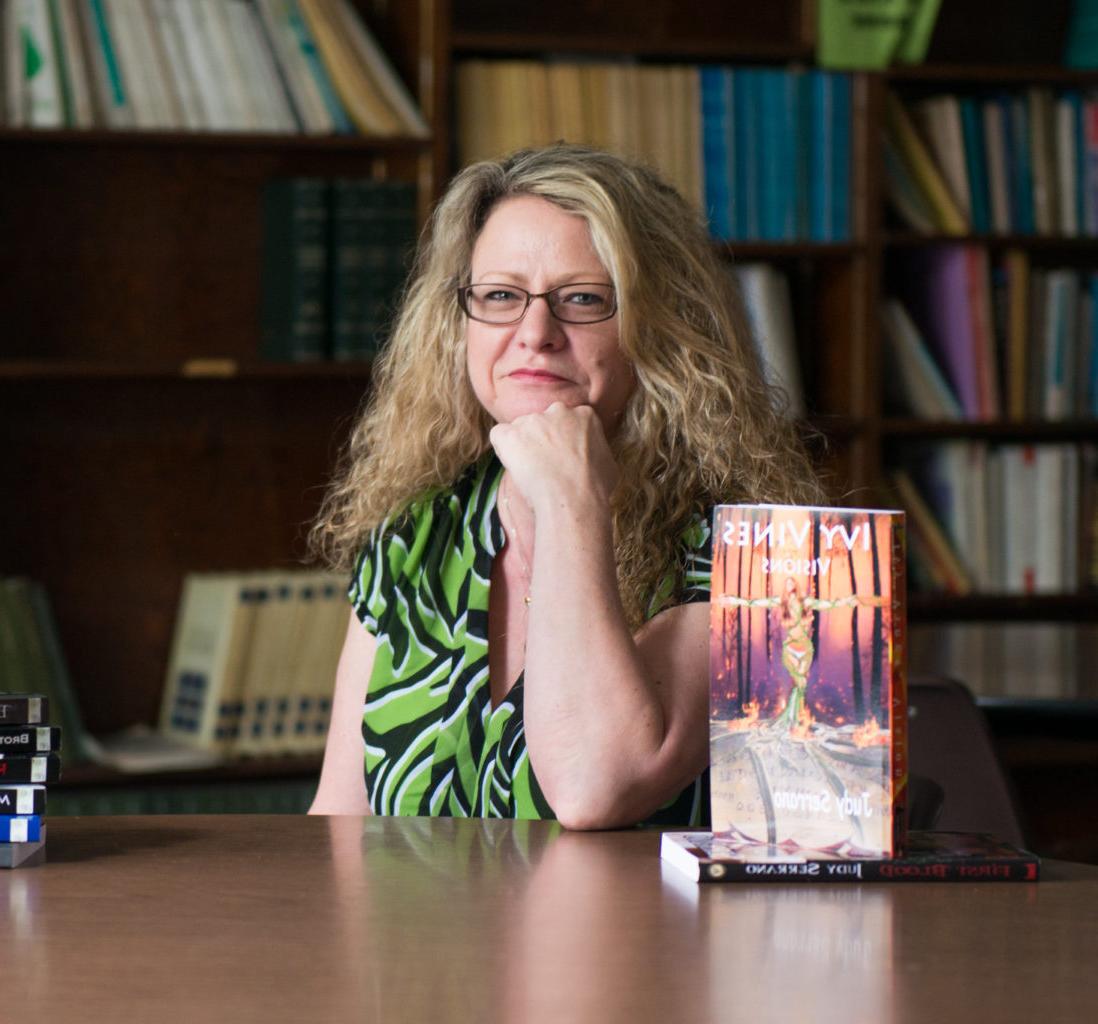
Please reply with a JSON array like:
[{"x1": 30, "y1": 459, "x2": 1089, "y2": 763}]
[{"x1": 0, "y1": 694, "x2": 61, "y2": 867}]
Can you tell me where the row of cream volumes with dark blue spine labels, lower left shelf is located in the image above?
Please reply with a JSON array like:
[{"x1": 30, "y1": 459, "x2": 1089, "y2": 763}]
[{"x1": 159, "y1": 571, "x2": 348, "y2": 758}]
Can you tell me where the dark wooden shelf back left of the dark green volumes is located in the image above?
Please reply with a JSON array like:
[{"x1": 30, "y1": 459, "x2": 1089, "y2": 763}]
[{"x1": 0, "y1": 139, "x2": 415, "y2": 361}]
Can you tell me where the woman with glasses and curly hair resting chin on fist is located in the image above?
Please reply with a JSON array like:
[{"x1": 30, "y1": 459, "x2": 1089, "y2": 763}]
[{"x1": 312, "y1": 144, "x2": 817, "y2": 829}]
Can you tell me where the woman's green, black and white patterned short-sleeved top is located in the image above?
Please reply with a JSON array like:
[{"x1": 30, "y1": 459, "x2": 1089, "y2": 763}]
[{"x1": 349, "y1": 454, "x2": 712, "y2": 824}]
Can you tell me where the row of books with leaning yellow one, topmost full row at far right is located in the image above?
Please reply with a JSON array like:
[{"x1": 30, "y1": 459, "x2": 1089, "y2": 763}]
[{"x1": 885, "y1": 86, "x2": 1098, "y2": 236}]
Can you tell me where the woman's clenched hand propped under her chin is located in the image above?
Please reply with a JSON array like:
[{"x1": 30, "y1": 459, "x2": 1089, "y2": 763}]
[{"x1": 489, "y1": 402, "x2": 618, "y2": 516}]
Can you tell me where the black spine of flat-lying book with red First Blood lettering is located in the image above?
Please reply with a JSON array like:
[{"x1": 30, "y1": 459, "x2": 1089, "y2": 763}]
[{"x1": 698, "y1": 857, "x2": 1040, "y2": 884}]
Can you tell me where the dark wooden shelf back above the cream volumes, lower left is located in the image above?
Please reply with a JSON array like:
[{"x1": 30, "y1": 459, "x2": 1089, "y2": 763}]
[{"x1": 0, "y1": 378, "x2": 363, "y2": 732}]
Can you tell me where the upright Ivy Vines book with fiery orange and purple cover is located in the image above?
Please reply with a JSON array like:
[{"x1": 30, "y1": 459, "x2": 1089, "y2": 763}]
[{"x1": 709, "y1": 505, "x2": 907, "y2": 857}]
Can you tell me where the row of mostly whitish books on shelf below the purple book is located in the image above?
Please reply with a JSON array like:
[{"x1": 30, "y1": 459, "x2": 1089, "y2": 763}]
[{"x1": 892, "y1": 441, "x2": 1098, "y2": 594}]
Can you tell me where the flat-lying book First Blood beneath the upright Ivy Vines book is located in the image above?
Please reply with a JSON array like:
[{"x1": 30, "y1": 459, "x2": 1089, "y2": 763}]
[{"x1": 660, "y1": 832, "x2": 1041, "y2": 882}]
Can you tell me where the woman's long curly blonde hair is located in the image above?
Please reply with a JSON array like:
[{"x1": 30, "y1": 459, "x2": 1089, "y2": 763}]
[{"x1": 310, "y1": 143, "x2": 820, "y2": 627}]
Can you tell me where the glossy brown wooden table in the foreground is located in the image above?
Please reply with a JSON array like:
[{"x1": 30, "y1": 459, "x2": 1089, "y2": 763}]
[{"x1": 0, "y1": 815, "x2": 1098, "y2": 1024}]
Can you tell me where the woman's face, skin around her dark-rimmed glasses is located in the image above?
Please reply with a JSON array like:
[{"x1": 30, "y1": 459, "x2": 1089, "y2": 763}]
[{"x1": 466, "y1": 195, "x2": 635, "y2": 436}]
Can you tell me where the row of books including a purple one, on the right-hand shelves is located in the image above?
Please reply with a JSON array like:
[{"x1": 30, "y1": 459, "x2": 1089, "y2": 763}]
[{"x1": 883, "y1": 244, "x2": 1098, "y2": 420}]
